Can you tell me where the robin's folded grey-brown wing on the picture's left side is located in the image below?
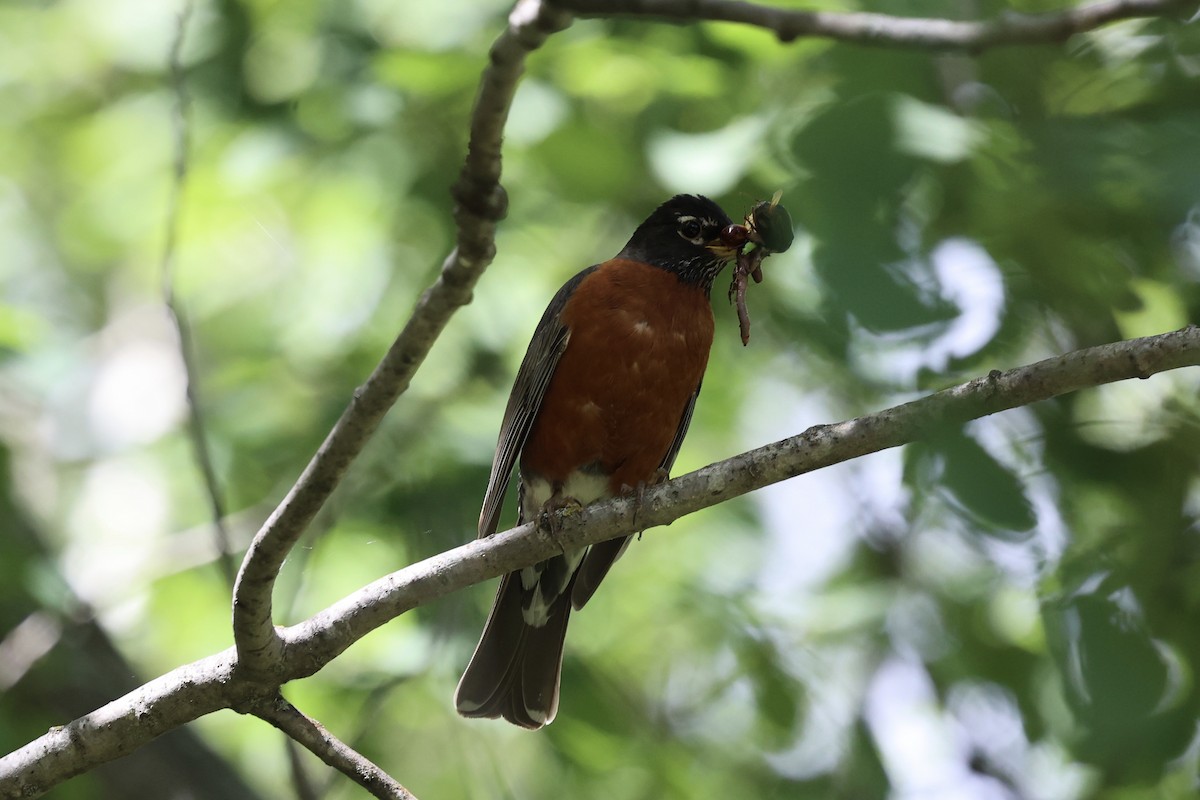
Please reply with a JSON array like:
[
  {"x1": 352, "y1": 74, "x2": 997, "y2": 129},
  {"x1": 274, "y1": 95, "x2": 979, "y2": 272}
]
[{"x1": 479, "y1": 266, "x2": 596, "y2": 539}]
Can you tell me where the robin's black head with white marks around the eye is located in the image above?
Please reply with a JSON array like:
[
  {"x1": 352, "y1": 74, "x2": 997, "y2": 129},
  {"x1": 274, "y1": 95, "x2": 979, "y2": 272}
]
[{"x1": 617, "y1": 194, "x2": 739, "y2": 291}]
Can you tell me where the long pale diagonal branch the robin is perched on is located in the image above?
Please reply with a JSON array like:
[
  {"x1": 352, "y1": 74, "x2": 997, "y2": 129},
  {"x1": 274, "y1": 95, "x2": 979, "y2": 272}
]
[{"x1": 0, "y1": 326, "x2": 1200, "y2": 798}]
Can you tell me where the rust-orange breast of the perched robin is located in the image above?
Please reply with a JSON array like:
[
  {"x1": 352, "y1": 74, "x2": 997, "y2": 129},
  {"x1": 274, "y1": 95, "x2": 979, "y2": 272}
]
[{"x1": 521, "y1": 259, "x2": 713, "y2": 494}]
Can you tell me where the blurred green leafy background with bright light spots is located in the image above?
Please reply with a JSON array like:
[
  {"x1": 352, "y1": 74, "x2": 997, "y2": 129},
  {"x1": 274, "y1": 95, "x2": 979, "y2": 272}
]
[{"x1": 0, "y1": 0, "x2": 1200, "y2": 800}]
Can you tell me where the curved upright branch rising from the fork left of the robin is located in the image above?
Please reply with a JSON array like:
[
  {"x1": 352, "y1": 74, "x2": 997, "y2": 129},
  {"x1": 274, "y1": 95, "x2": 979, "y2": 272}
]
[{"x1": 233, "y1": 0, "x2": 566, "y2": 680}]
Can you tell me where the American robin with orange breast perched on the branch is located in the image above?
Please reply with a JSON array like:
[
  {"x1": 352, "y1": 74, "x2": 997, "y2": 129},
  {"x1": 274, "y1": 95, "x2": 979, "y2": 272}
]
[{"x1": 455, "y1": 194, "x2": 744, "y2": 729}]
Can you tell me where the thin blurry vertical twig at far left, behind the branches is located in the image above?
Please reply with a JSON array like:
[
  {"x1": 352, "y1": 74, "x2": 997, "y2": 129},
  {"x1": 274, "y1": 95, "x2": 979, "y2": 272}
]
[{"x1": 162, "y1": 0, "x2": 236, "y2": 588}]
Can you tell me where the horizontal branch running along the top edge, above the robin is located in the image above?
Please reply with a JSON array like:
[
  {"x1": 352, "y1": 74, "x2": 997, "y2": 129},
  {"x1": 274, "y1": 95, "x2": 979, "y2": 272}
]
[{"x1": 554, "y1": 0, "x2": 1195, "y2": 52}]
